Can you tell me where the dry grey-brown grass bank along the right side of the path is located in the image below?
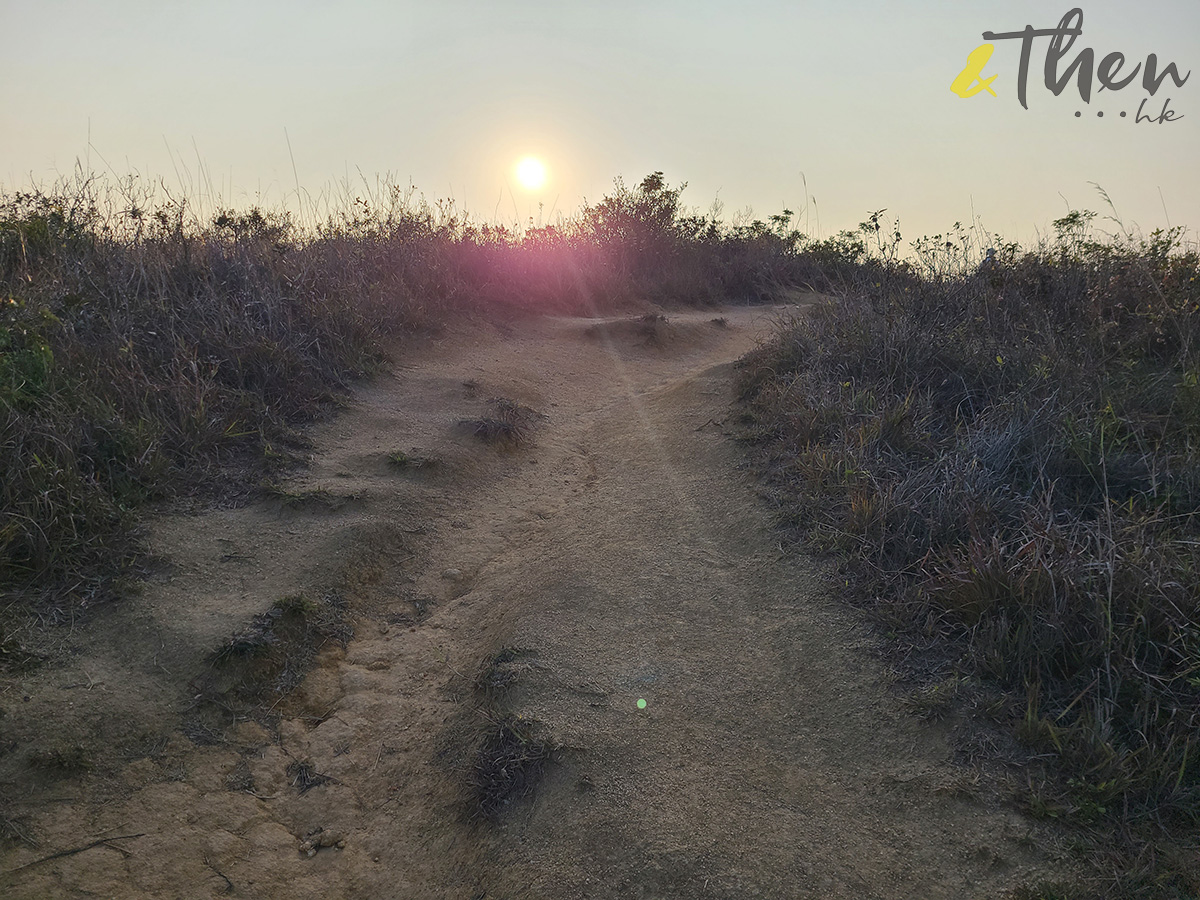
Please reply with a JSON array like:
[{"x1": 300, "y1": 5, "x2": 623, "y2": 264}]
[{"x1": 742, "y1": 214, "x2": 1200, "y2": 896}]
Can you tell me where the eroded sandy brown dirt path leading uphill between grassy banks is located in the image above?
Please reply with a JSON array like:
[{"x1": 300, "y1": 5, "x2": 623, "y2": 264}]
[{"x1": 0, "y1": 308, "x2": 1070, "y2": 900}]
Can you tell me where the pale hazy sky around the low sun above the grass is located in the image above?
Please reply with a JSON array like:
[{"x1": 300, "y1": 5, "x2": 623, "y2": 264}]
[{"x1": 0, "y1": 0, "x2": 1200, "y2": 247}]
